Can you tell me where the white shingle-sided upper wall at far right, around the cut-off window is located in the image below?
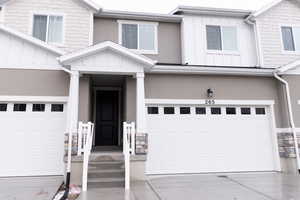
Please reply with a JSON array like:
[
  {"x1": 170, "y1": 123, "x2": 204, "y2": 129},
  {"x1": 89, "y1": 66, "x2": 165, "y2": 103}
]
[{"x1": 256, "y1": 0, "x2": 300, "y2": 67}]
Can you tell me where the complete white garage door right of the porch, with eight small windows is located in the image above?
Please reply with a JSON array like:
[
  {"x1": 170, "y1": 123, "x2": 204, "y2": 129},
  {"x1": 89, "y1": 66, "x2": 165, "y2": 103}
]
[{"x1": 146, "y1": 105, "x2": 276, "y2": 174}]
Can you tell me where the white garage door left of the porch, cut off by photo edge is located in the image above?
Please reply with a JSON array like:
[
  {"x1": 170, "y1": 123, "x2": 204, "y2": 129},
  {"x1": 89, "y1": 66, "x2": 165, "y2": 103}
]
[{"x1": 0, "y1": 103, "x2": 66, "y2": 177}]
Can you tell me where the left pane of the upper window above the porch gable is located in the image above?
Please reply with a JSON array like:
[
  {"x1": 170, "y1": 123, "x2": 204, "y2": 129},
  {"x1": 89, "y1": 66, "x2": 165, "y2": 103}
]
[{"x1": 122, "y1": 24, "x2": 137, "y2": 49}]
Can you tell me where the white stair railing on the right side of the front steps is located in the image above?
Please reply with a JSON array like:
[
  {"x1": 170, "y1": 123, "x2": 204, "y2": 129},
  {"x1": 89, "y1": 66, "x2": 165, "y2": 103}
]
[{"x1": 123, "y1": 122, "x2": 135, "y2": 190}]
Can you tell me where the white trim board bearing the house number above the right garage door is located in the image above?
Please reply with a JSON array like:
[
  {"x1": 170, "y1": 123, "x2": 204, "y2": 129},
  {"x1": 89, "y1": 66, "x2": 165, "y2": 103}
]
[{"x1": 145, "y1": 99, "x2": 275, "y2": 106}]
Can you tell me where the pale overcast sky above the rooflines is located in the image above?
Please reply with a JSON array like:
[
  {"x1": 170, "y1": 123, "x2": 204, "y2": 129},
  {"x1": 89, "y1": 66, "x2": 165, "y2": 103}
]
[{"x1": 93, "y1": 0, "x2": 272, "y2": 14}]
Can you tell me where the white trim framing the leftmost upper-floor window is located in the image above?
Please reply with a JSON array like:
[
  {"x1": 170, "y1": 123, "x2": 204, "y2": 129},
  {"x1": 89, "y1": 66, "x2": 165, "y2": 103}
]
[{"x1": 29, "y1": 11, "x2": 66, "y2": 47}]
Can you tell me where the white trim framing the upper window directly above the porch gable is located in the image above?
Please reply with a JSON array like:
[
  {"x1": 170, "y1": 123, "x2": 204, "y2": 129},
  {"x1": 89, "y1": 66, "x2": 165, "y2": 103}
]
[{"x1": 118, "y1": 20, "x2": 159, "y2": 55}]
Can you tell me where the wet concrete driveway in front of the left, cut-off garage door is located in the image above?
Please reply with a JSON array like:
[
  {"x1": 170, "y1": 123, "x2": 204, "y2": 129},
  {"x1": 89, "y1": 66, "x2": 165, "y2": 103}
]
[{"x1": 0, "y1": 176, "x2": 63, "y2": 200}]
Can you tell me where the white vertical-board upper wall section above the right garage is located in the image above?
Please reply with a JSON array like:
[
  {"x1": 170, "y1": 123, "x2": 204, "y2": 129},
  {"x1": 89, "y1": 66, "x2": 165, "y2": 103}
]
[{"x1": 182, "y1": 15, "x2": 257, "y2": 67}]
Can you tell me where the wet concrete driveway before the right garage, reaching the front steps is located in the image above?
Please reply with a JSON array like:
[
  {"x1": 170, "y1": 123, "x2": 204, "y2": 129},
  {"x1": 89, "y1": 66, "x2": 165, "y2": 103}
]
[{"x1": 79, "y1": 173, "x2": 300, "y2": 200}]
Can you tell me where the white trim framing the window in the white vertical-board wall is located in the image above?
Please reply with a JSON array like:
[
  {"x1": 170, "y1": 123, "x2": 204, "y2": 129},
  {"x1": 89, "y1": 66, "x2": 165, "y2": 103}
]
[{"x1": 204, "y1": 24, "x2": 240, "y2": 55}]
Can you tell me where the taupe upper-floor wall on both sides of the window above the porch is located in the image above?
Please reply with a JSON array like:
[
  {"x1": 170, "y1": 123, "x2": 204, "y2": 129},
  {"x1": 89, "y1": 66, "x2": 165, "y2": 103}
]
[{"x1": 94, "y1": 18, "x2": 181, "y2": 64}]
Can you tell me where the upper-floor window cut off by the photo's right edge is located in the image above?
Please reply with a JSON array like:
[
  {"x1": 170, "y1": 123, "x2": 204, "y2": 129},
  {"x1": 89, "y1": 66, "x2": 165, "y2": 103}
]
[{"x1": 281, "y1": 26, "x2": 300, "y2": 51}]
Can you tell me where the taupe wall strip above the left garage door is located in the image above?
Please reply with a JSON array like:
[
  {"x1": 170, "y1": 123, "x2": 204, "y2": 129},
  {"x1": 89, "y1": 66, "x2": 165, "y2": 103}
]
[{"x1": 0, "y1": 69, "x2": 69, "y2": 96}]
